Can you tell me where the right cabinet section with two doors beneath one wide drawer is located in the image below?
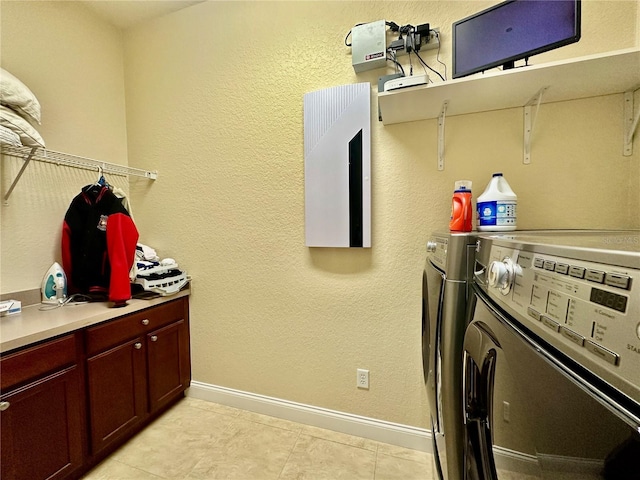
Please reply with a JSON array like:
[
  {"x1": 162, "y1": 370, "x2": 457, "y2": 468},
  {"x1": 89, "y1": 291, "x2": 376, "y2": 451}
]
[{"x1": 86, "y1": 298, "x2": 191, "y2": 455}]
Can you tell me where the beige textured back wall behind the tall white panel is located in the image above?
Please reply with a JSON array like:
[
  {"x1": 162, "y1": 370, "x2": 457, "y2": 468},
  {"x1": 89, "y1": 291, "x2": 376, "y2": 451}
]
[{"x1": 125, "y1": 1, "x2": 640, "y2": 426}]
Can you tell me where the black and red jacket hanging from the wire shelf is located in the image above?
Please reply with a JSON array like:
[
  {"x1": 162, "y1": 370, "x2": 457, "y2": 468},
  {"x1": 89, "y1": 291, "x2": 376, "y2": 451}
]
[{"x1": 62, "y1": 184, "x2": 138, "y2": 304}]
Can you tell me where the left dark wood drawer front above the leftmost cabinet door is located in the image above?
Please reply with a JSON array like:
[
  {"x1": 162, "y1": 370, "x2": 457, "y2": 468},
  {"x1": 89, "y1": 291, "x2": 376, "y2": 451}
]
[{"x1": 0, "y1": 334, "x2": 76, "y2": 391}]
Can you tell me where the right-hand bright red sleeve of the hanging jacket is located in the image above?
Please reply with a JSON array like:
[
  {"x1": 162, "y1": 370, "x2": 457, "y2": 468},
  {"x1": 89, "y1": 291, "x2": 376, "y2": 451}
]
[{"x1": 107, "y1": 213, "x2": 138, "y2": 303}]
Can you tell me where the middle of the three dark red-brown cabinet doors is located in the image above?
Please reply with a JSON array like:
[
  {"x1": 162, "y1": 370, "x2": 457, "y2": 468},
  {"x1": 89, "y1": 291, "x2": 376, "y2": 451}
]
[{"x1": 87, "y1": 337, "x2": 147, "y2": 454}]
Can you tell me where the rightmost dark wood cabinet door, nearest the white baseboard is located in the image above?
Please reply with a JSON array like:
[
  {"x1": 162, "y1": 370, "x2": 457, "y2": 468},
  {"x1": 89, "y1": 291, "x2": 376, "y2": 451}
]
[{"x1": 147, "y1": 320, "x2": 191, "y2": 412}]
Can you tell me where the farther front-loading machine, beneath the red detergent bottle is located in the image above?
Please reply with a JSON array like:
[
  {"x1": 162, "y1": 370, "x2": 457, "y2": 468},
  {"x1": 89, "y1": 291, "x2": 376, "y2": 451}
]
[{"x1": 422, "y1": 232, "x2": 476, "y2": 480}]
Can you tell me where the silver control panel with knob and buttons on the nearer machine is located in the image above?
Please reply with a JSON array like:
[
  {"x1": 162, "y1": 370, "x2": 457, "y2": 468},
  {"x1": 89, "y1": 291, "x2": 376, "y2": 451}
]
[{"x1": 476, "y1": 244, "x2": 640, "y2": 401}]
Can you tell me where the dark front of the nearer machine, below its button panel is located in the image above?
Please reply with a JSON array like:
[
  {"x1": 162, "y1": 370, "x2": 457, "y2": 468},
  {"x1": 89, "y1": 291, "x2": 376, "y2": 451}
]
[{"x1": 464, "y1": 287, "x2": 640, "y2": 480}]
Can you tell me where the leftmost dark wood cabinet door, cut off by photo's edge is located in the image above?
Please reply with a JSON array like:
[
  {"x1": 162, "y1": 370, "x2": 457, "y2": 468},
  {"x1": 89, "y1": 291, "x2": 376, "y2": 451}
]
[{"x1": 0, "y1": 366, "x2": 85, "y2": 480}]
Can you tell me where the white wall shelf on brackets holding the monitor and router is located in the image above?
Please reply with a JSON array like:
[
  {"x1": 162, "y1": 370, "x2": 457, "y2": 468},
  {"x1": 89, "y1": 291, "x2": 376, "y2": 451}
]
[{"x1": 378, "y1": 48, "x2": 640, "y2": 125}]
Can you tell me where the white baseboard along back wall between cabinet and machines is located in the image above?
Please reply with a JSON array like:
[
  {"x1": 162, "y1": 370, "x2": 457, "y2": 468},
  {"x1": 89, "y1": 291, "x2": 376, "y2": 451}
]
[{"x1": 187, "y1": 381, "x2": 432, "y2": 453}]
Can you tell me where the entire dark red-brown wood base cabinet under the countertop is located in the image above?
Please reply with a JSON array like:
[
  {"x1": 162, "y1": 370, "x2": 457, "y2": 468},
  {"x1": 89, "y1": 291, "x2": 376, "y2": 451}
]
[{"x1": 0, "y1": 296, "x2": 191, "y2": 480}]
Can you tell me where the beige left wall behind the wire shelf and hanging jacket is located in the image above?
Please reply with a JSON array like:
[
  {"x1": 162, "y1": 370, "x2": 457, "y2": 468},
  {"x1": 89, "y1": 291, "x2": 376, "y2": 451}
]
[{"x1": 0, "y1": 1, "x2": 128, "y2": 293}]
